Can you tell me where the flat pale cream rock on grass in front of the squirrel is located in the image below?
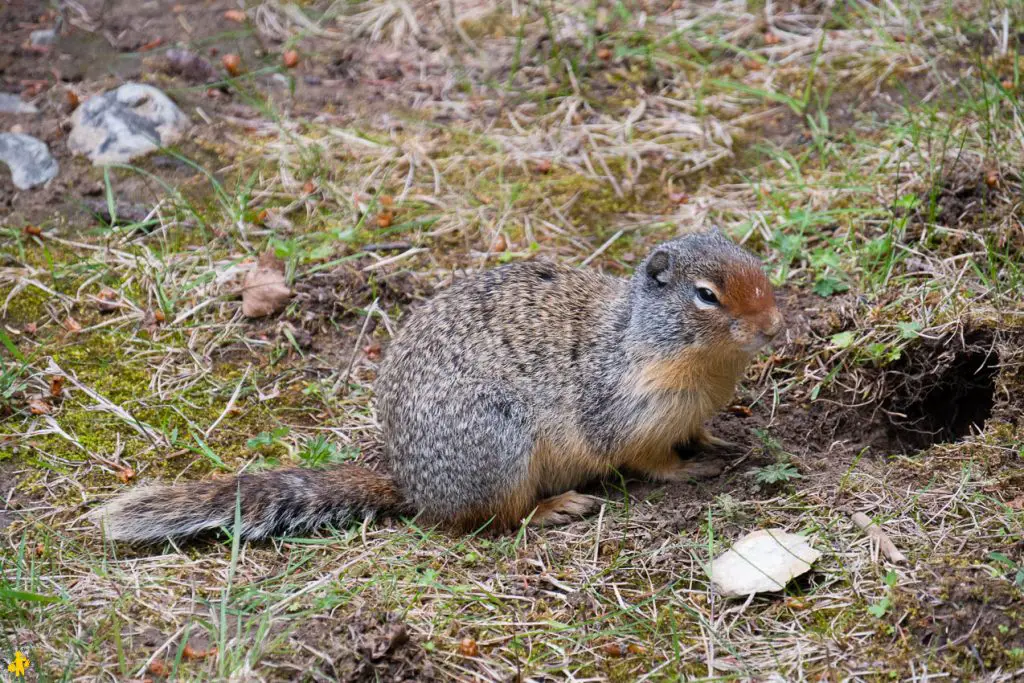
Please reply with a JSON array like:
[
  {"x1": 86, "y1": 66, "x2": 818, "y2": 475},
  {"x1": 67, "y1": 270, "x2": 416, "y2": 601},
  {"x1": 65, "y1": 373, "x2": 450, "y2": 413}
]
[{"x1": 708, "y1": 529, "x2": 821, "y2": 597}]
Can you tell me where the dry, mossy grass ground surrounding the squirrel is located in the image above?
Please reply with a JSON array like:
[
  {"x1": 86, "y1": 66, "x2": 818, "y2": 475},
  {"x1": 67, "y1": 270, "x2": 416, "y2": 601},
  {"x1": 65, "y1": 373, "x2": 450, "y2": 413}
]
[{"x1": 0, "y1": 0, "x2": 1024, "y2": 681}]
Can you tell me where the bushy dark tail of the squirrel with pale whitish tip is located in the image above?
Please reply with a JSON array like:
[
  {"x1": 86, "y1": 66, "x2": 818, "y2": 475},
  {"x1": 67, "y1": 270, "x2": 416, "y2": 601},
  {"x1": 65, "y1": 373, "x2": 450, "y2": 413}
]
[{"x1": 89, "y1": 464, "x2": 412, "y2": 542}]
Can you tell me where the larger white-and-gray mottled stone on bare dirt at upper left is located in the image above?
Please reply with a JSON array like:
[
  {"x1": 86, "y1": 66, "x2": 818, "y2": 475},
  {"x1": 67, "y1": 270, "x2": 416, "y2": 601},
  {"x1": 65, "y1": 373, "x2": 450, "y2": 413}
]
[{"x1": 68, "y1": 83, "x2": 190, "y2": 166}]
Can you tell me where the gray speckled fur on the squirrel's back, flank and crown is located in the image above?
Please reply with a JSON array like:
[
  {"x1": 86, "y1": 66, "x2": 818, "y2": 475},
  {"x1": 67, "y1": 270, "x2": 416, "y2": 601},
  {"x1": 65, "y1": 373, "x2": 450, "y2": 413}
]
[{"x1": 377, "y1": 231, "x2": 760, "y2": 520}]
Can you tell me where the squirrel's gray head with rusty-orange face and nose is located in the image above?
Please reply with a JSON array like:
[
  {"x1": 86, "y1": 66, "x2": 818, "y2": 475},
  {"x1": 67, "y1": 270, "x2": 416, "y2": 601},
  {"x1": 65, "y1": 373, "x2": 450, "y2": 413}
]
[{"x1": 631, "y1": 229, "x2": 782, "y2": 355}]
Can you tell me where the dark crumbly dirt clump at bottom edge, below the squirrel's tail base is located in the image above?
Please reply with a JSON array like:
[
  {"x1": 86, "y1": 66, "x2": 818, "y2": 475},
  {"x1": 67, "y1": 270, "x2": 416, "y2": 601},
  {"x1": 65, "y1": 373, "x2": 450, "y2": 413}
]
[{"x1": 276, "y1": 612, "x2": 438, "y2": 682}]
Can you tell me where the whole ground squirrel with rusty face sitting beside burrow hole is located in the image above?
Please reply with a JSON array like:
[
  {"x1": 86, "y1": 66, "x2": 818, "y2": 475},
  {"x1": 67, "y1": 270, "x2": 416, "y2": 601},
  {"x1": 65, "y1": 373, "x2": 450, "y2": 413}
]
[{"x1": 91, "y1": 230, "x2": 782, "y2": 542}]
